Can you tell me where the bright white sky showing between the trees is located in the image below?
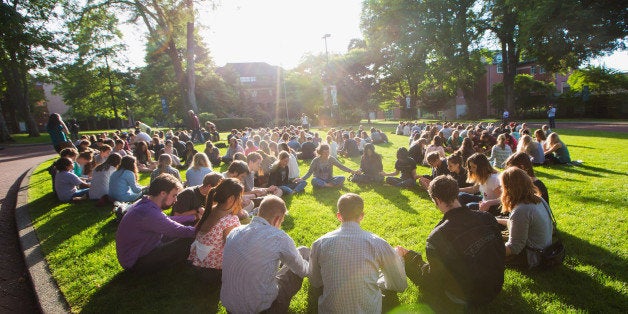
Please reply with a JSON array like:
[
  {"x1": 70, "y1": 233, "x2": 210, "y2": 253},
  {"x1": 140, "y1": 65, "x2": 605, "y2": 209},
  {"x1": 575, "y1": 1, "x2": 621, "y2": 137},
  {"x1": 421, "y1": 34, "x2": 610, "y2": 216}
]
[{"x1": 127, "y1": 0, "x2": 628, "y2": 72}]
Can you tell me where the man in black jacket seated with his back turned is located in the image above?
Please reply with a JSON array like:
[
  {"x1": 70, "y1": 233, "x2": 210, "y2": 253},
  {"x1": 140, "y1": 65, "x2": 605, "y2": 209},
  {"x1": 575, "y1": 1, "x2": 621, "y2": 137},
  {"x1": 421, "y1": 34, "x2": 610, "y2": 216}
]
[{"x1": 397, "y1": 176, "x2": 505, "y2": 312}]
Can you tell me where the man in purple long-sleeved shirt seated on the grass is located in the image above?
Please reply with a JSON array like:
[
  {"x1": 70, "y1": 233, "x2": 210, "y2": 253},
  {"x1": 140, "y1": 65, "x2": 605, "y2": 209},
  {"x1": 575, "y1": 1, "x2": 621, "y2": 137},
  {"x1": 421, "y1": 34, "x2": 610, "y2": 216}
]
[{"x1": 116, "y1": 174, "x2": 203, "y2": 273}]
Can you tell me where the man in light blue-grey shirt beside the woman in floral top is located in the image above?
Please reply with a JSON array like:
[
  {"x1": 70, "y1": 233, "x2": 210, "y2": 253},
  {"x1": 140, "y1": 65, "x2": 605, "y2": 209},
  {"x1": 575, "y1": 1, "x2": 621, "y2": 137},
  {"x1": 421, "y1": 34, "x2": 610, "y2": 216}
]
[{"x1": 220, "y1": 195, "x2": 310, "y2": 313}]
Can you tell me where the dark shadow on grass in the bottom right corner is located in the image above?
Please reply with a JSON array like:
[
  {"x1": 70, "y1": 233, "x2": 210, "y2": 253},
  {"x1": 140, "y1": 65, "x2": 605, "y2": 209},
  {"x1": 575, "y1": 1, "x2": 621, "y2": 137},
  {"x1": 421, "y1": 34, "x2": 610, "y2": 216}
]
[{"x1": 471, "y1": 232, "x2": 628, "y2": 313}]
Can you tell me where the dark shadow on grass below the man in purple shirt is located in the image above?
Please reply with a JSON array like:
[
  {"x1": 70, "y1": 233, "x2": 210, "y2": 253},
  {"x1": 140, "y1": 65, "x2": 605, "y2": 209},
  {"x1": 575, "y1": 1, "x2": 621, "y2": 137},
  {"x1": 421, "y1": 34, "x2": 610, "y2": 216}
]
[{"x1": 81, "y1": 263, "x2": 220, "y2": 313}]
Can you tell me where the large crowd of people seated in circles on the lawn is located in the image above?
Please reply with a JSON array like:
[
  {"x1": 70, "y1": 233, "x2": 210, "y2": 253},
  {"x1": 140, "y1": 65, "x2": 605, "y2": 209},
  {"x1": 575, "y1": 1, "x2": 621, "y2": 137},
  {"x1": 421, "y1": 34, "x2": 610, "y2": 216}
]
[{"x1": 46, "y1": 113, "x2": 571, "y2": 313}]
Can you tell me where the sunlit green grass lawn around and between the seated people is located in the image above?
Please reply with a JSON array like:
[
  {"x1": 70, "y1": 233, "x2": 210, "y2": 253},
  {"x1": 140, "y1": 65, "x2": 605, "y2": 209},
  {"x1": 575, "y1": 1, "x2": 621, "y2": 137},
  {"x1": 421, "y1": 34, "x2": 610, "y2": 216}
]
[{"x1": 29, "y1": 125, "x2": 628, "y2": 313}]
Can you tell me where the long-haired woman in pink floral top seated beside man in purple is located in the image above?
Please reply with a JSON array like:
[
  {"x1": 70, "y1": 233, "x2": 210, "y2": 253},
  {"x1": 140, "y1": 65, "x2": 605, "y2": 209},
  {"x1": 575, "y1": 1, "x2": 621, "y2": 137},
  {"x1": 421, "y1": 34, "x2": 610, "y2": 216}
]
[{"x1": 188, "y1": 179, "x2": 244, "y2": 288}]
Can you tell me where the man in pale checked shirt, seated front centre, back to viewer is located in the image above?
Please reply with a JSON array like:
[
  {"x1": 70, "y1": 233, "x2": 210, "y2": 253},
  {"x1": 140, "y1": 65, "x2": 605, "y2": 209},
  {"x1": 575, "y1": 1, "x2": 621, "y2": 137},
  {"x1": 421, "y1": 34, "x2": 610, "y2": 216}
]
[{"x1": 309, "y1": 193, "x2": 407, "y2": 313}]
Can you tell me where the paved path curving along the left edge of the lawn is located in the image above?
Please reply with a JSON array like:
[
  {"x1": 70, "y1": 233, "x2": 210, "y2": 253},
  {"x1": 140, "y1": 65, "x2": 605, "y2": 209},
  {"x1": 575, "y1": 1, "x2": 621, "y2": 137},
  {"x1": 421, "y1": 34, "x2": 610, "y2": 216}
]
[{"x1": 0, "y1": 145, "x2": 55, "y2": 313}]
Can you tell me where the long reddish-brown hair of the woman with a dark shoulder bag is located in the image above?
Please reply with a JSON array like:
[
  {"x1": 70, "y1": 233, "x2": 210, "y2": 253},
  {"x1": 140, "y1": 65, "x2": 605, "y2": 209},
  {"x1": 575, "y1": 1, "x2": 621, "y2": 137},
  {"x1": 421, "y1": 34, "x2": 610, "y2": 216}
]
[{"x1": 499, "y1": 167, "x2": 541, "y2": 213}]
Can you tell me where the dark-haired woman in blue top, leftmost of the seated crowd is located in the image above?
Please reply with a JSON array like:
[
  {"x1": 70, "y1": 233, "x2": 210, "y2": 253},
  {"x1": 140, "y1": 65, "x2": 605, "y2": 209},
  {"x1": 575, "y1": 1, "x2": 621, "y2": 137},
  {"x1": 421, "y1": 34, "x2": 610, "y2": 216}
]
[{"x1": 54, "y1": 157, "x2": 89, "y2": 202}]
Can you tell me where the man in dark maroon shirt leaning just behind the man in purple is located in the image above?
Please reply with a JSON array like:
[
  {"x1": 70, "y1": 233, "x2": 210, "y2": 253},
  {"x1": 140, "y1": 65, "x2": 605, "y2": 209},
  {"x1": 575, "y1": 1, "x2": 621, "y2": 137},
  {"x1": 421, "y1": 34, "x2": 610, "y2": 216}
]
[{"x1": 170, "y1": 172, "x2": 222, "y2": 216}]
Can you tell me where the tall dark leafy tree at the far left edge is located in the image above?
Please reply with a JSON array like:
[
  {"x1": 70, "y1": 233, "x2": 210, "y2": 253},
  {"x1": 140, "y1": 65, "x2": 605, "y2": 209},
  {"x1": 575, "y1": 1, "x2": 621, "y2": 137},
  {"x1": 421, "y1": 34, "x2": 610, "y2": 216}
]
[{"x1": 0, "y1": 0, "x2": 60, "y2": 137}]
